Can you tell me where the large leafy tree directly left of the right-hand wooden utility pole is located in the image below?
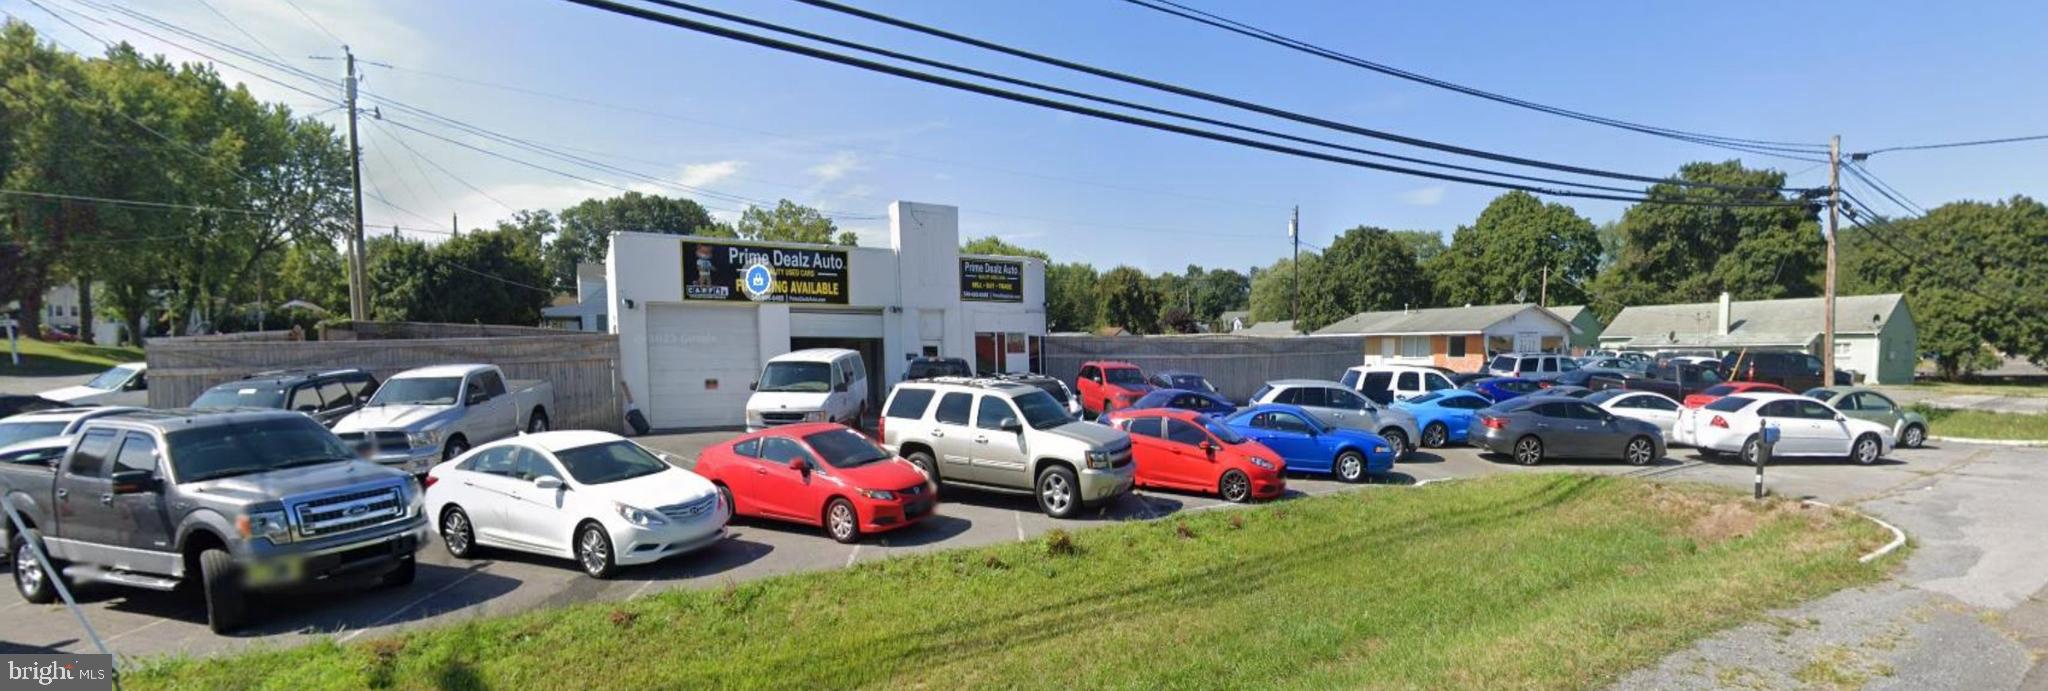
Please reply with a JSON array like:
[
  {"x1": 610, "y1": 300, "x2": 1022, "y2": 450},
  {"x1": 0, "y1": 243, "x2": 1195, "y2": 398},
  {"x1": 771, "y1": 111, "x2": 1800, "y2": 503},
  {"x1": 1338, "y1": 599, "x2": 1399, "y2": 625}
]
[{"x1": 1597, "y1": 160, "x2": 1825, "y2": 318}]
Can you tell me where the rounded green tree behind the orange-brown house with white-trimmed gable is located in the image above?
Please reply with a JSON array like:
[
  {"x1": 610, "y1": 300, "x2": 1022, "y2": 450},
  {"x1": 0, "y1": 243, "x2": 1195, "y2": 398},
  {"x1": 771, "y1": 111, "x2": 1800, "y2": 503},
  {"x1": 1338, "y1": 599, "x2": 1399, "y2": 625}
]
[{"x1": 1427, "y1": 191, "x2": 1599, "y2": 306}]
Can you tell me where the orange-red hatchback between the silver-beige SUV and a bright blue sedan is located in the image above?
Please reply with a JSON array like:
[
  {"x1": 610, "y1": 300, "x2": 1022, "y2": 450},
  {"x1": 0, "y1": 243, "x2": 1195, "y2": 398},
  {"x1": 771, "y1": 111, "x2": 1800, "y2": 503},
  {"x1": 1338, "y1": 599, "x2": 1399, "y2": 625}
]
[{"x1": 1110, "y1": 408, "x2": 1286, "y2": 502}]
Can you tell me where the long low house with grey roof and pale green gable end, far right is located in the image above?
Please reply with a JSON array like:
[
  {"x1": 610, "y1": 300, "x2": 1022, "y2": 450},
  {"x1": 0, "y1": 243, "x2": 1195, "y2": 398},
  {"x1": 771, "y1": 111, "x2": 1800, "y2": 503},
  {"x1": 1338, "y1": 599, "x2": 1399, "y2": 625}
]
[{"x1": 1599, "y1": 293, "x2": 1919, "y2": 383}]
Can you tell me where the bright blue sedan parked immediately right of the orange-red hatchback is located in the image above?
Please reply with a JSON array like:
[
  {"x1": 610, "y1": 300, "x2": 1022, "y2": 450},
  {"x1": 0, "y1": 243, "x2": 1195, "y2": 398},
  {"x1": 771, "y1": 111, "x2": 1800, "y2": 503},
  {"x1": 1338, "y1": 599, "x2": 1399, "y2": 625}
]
[{"x1": 1223, "y1": 404, "x2": 1395, "y2": 482}]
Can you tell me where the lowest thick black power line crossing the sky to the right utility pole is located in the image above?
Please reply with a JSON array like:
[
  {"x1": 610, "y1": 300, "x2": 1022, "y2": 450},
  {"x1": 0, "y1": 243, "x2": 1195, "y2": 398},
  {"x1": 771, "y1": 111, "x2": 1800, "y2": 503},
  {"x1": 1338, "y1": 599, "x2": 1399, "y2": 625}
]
[{"x1": 567, "y1": 0, "x2": 1796, "y2": 207}]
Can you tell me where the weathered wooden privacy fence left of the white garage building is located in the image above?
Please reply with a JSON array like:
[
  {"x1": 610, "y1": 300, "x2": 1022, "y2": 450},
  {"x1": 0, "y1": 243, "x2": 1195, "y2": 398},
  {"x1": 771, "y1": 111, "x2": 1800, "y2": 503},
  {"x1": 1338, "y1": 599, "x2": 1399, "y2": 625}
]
[{"x1": 143, "y1": 322, "x2": 625, "y2": 433}]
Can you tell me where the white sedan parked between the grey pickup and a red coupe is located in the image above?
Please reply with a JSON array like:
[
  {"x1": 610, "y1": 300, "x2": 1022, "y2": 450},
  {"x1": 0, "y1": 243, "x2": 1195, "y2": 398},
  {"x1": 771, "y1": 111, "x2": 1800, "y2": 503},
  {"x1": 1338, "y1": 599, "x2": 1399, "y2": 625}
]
[{"x1": 426, "y1": 431, "x2": 731, "y2": 578}]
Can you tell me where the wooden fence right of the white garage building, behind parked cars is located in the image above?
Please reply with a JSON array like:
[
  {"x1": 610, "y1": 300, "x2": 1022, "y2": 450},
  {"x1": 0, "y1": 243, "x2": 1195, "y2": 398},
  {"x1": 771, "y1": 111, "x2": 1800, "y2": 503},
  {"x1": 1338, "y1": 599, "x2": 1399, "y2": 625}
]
[{"x1": 1042, "y1": 334, "x2": 1366, "y2": 402}]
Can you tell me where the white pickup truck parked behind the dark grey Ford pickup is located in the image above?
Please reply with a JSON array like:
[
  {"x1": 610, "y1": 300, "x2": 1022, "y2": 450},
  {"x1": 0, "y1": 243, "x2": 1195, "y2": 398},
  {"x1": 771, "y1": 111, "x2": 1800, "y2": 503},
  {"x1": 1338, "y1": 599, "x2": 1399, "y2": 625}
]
[{"x1": 334, "y1": 365, "x2": 555, "y2": 476}]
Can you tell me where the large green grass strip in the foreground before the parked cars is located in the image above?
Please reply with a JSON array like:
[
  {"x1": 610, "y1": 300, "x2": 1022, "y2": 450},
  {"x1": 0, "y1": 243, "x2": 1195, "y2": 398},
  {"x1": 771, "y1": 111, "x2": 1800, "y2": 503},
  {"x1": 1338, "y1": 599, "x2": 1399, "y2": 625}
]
[{"x1": 127, "y1": 474, "x2": 1896, "y2": 691}]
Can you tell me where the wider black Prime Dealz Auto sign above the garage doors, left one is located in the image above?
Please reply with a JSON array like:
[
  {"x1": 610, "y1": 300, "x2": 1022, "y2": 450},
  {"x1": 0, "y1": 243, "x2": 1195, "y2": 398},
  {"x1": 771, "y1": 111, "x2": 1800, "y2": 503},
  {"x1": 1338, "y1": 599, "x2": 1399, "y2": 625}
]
[{"x1": 682, "y1": 242, "x2": 846, "y2": 306}]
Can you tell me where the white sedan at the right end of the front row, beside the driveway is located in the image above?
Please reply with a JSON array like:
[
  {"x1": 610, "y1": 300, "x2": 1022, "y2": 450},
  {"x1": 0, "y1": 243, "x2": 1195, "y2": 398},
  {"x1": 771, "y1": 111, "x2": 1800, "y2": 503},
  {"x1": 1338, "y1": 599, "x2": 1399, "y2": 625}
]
[{"x1": 1673, "y1": 394, "x2": 1892, "y2": 465}]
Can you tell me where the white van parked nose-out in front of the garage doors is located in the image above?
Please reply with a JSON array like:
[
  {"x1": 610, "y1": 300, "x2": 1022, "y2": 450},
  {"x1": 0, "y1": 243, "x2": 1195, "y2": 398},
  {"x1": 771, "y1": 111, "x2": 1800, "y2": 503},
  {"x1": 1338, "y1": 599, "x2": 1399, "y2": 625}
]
[{"x1": 748, "y1": 349, "x2": 868, "y2": 433}]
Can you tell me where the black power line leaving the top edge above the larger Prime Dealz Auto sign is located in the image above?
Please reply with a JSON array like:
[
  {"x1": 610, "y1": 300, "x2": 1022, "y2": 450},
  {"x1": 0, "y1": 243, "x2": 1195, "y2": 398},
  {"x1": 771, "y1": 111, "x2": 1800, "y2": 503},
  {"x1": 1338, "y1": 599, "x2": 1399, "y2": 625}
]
[{"x1": 778, "y1": 0, "x2": 1810, "y2": 191}]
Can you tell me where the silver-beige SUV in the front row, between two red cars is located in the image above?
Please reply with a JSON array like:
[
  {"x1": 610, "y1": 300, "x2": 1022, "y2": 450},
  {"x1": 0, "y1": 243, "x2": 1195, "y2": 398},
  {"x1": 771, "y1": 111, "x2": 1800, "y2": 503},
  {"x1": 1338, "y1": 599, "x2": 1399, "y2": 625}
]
[{"x1": 879, "y1": 377, "x2": 1137, "y2": 519}]
